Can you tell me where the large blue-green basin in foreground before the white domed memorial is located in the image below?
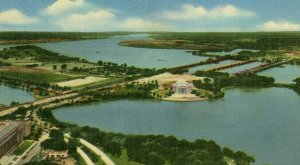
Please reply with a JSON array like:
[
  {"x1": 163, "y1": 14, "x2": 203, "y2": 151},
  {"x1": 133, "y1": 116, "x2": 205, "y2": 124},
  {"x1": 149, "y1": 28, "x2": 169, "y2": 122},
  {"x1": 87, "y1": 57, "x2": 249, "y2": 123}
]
[{"x1": 53, "y1": 88, "x2": 300, "y2": 165}]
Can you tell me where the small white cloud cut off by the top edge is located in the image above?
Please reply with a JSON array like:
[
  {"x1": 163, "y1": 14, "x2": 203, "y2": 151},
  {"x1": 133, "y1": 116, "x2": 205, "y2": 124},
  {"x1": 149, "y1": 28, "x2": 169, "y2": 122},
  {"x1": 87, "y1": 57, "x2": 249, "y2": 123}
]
[{"x1": 44, "y1": 0, "x2": 85, "y2": 15}]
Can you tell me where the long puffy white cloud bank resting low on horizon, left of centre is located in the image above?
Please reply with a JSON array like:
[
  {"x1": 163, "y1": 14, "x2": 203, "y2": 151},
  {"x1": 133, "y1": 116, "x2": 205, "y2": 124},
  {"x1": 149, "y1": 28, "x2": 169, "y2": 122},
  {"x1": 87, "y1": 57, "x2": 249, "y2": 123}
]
[{"x1": 56, "y1": 9, "x2": 169, "y2": 31}]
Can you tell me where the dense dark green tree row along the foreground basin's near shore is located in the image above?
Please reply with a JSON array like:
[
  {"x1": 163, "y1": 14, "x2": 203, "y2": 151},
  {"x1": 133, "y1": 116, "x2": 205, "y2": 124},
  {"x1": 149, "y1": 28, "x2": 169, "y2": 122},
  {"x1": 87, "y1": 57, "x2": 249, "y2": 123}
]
[{"x1": 67, "y1": 126, "x2": 254, "y2": 165}]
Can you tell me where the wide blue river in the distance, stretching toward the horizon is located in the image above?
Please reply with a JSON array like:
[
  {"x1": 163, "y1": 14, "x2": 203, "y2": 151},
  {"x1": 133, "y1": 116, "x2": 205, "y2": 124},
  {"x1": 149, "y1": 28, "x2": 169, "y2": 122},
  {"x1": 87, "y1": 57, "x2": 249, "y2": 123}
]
[{"x1": 36, "y1": 34, "x2": 207, "y2": 68}]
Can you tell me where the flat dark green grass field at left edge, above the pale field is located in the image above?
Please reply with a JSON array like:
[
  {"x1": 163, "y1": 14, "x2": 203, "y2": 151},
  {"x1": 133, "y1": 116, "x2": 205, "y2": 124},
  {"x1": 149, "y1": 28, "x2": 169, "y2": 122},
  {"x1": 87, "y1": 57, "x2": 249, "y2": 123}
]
[{"x1": 0, "y1": 70, "x2": 74, "y2": 83}]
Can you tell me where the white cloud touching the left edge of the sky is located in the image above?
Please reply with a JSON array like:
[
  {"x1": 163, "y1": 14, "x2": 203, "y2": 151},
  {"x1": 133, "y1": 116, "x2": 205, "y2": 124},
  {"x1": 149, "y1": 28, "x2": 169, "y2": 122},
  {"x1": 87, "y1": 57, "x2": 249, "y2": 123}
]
[{"x1": 0, "y1": 9, "x2": 38, "y2": 25}]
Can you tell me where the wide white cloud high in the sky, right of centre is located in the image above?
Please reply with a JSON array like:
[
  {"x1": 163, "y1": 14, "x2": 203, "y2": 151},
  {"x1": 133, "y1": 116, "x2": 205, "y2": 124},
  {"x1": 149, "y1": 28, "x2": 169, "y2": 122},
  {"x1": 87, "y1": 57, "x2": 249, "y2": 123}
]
[{"x1": 162, "y1": 4, "x2": 255, "y2": 20}]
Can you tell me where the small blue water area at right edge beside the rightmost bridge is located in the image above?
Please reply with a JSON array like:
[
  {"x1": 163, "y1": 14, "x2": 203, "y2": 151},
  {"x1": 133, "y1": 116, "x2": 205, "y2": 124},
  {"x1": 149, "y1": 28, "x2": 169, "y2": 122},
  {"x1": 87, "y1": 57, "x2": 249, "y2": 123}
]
[{"x1": 258, "y1": 64, "x2": 300, "y2": 84}]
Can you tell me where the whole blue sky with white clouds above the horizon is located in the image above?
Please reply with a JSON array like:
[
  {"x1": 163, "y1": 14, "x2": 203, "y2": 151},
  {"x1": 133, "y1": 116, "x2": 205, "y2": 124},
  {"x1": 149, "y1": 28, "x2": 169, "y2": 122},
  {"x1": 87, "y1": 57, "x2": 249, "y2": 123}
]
[{"x1": 0, "y1": 0, "x2": 300, "y2": 32}]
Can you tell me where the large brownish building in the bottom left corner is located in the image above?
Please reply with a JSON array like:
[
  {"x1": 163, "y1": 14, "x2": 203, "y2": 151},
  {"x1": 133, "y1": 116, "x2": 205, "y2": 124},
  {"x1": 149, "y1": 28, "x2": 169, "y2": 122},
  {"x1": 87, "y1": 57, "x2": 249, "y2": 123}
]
[{"x1": 0, "y1": 121, "x2": 30, "y2": 158}]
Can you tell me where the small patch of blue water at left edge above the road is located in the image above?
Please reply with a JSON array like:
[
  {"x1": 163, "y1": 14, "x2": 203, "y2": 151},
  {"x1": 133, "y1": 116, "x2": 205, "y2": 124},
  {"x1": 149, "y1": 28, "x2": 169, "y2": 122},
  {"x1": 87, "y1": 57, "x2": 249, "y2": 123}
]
[{"x1": 0, "y1": 85, "x2": 34, "y2": 105}]
